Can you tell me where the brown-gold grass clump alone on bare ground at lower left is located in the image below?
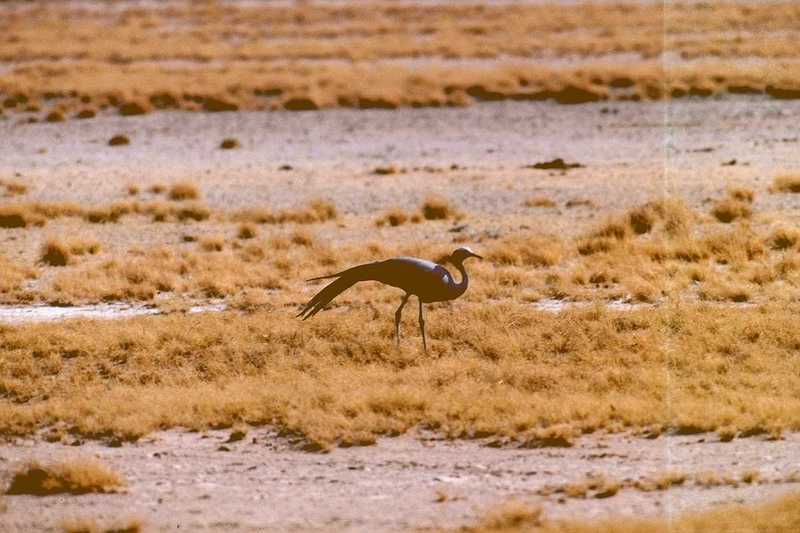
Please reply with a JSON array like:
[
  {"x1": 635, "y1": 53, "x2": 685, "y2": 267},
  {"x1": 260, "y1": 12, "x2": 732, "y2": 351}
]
[{"x1": 6, "y1": 459, "x2": 125, "y2": 496}]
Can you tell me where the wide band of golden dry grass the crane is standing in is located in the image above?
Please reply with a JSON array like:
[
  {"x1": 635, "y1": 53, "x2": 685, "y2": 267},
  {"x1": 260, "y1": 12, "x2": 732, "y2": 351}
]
[{"x1": 0, "y1": 300, "x2": 800, "y2": 447}]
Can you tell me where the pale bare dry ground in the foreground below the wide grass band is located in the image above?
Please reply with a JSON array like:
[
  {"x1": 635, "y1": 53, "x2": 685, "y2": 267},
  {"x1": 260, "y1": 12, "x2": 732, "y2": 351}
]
[{"x1": 0, "y1": 429, "x2": 800, "y2": 531}]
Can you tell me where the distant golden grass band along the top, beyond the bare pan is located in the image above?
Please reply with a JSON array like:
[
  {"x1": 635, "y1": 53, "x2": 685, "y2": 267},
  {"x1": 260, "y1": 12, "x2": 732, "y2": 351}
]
[{"x1": 0, "y1": 3, "x2": 800, "y2": 116}]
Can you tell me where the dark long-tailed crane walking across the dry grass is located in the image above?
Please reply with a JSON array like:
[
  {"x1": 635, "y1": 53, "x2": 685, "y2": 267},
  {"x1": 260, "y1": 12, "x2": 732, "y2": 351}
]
[{"x1": 297, "y1": 247, "x2": 483, "y2": 353}]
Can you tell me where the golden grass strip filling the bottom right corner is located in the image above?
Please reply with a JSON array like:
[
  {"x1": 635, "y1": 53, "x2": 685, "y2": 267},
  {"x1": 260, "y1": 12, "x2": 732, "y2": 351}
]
[{"x1": 463, "y1": 494, "x2": 800, "y2": 533}]
